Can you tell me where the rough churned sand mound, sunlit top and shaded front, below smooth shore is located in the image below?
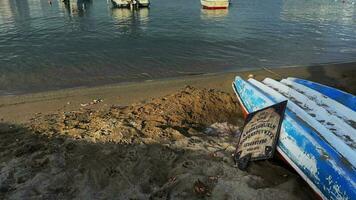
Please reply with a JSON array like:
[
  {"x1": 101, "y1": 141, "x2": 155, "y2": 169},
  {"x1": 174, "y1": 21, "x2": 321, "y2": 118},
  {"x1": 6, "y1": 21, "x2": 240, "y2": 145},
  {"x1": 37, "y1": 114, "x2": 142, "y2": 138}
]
[{"x1": 0, "y1": 87, "x2": 310, "y2": 199}]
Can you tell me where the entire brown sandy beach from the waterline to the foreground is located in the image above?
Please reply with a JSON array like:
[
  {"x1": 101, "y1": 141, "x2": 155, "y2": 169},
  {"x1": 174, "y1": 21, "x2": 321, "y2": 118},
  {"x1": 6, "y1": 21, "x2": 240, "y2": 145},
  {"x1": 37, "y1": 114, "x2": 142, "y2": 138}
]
[{"x1": 0, "y1": 63, "x2": 356, "y2": 200}]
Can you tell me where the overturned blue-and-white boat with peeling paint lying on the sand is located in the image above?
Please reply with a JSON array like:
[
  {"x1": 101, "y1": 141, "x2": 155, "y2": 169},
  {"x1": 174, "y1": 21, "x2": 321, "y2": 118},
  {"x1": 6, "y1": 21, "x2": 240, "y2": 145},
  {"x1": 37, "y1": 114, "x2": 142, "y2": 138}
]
[{"x1": 233, "y1": 77, "x2": 356, "y2": 200}]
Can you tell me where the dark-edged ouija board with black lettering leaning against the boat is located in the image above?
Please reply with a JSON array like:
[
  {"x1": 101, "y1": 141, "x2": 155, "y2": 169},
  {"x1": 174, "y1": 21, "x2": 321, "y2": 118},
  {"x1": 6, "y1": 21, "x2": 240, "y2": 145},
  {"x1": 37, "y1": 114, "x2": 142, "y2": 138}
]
[{"x1": 234, "y1": 101, "x2": 287, "y2": 169}]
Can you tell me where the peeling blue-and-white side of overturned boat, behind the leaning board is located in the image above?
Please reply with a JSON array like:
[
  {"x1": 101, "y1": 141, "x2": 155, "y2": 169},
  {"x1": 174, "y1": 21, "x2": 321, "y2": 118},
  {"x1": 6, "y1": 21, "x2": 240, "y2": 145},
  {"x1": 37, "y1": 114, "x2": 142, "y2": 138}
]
[{"x1": 233, "y1": 77, "x2": 356, "y2": 199}]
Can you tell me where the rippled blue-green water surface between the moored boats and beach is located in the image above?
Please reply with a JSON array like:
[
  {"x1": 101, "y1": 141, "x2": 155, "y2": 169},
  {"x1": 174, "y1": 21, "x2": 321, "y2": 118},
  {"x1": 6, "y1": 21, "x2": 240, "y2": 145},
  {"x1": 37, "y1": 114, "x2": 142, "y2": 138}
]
[{"x1": 0, "y1": 0, "x2": 356, "y2": 95}]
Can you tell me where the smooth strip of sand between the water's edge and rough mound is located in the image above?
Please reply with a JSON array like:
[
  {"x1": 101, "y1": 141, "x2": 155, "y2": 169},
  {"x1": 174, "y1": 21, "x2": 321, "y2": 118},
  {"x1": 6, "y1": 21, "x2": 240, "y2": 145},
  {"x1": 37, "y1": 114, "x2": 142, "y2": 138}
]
[{"x1": 0, "y1": 63, "x2": 356, "y2": 123}]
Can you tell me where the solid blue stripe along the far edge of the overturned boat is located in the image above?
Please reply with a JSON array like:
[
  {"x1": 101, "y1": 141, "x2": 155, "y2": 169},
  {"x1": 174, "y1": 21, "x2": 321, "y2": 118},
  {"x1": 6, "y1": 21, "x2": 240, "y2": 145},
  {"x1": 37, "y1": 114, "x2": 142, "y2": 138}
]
[{"x1": 288, "y1": 78, "x2": 356, "y2": 111}]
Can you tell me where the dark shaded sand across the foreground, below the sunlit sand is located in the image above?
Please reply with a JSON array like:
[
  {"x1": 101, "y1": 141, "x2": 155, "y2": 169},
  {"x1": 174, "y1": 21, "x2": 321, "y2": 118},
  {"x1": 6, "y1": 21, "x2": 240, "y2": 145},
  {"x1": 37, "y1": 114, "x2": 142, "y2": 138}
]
[{"x1": 0, "y1": 124, "x2": 311, "y2": 199}]
